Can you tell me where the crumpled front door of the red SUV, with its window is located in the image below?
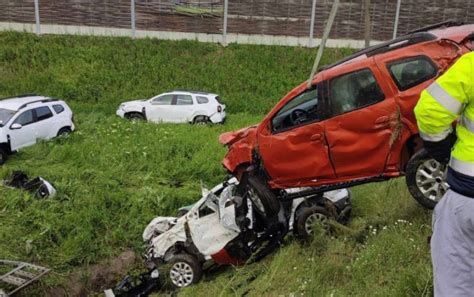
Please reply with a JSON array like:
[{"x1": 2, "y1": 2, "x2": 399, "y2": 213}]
[{"x1": 258, "y1": 85, "x2": 335, "y2": 188}]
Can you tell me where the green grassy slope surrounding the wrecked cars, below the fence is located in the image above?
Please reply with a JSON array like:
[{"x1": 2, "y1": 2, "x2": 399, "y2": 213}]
[{"x1": 0, "y1": 32, "x2": 432, "y2": 296}]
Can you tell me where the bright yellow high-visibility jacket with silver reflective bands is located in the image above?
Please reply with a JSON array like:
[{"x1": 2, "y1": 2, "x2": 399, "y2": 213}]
[{"x1": 415, "y1": 52, "x2": 474, "y2": 177}]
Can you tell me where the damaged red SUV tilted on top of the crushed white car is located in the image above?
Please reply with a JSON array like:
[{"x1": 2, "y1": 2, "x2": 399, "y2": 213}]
[{"x1": 219, "y1": 22, "x2": 474, "y2": 214}]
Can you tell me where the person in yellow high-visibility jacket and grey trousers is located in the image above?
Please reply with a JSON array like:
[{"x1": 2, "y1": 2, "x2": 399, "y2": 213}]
[{"x1": 415, "y1": 52, "x2": 474, "y2": 297}]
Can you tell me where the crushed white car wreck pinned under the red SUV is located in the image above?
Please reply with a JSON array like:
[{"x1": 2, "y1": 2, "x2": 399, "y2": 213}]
[{"x1": 143, "y1": 178, "x2": 351, "y2": 288}]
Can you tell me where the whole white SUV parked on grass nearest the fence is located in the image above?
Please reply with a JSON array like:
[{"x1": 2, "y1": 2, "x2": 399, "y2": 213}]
[{"x1": 117, "y1": 90, "x2": 226, "y2": 124}]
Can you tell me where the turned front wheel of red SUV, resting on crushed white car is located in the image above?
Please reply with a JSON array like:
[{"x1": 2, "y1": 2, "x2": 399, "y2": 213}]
[{"x1": 248, "y1": 175, "x2": 280, "y2": 218}]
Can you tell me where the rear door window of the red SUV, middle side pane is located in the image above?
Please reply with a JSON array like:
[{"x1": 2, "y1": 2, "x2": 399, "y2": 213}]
[{"x1": 329, "y1": 69, "x2": 385, "y2": 116}]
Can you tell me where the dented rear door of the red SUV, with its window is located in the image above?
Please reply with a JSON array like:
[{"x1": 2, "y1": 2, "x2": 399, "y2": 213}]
[{"x1": 325, "y1": 62, "x2": 399, "y2": 181}]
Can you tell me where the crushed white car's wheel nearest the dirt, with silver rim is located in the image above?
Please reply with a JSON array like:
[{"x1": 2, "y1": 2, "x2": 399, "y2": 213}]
[{"x1": 168, "y1": 254, "x2": 202, "y2": 289}]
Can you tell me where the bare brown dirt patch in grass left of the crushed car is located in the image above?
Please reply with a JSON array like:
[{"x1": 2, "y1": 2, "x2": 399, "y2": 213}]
[{"x1": 47, "y1": 250, "x2": 142, "y2": 297}]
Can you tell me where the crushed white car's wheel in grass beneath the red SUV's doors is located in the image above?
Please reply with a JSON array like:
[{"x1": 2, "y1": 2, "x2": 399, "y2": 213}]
[{"x1": 294, "y1": 206, "x2": 331, "y2": 241}]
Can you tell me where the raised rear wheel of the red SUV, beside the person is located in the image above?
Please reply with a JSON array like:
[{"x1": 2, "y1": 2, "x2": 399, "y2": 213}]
[{"x1": 405, "y1": 149, "x2": 448, "y2": 209}]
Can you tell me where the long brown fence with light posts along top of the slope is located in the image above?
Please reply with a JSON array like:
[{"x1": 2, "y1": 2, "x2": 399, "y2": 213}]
[{"x1": 0, "y1": 0, "x2": 474, "y2": 46}]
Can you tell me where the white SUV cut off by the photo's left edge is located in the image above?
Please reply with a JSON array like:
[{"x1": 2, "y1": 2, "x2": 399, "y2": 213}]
[{"x1": 0, "y1": 95, "x2": 75, "y2": 165}]
